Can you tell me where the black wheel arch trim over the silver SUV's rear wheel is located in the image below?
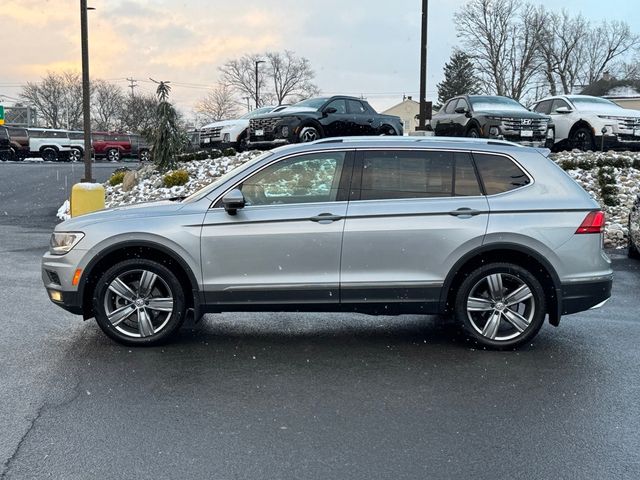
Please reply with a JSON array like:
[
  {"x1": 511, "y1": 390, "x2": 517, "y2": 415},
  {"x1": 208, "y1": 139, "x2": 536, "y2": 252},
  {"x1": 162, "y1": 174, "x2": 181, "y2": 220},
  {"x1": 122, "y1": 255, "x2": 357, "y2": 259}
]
[{"x1": 440, "y1": 243, "x2": 562, "y2": 326}]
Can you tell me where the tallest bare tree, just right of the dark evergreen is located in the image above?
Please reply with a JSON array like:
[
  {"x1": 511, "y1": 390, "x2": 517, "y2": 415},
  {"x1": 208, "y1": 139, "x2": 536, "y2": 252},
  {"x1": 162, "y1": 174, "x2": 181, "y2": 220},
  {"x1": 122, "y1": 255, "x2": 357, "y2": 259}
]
[{"x1": 455, "y1": 0, "x2": 542, "y2": 99}]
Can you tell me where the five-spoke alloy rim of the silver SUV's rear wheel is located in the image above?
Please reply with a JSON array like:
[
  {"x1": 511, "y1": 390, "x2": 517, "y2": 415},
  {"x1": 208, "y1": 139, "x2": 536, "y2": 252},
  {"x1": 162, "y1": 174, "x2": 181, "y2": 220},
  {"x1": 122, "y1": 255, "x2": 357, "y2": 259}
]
[{"x1": 466, "y1": 273, "x2": 536, "y2": 341}]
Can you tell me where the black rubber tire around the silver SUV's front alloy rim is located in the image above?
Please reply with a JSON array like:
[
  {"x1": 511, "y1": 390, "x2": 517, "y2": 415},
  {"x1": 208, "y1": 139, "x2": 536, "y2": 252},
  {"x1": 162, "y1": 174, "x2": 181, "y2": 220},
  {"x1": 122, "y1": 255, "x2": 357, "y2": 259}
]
[{"x1": 93, "y1": 259, "x2": 186, "y2": 346}]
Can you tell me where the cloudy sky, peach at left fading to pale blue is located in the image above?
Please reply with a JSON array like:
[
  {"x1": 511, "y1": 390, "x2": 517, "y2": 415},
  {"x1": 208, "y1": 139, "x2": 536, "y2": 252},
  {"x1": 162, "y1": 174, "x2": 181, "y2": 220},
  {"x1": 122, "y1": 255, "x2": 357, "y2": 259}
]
[{"x1": 0, "y1": 0, "x2": 640, "y2": 118}]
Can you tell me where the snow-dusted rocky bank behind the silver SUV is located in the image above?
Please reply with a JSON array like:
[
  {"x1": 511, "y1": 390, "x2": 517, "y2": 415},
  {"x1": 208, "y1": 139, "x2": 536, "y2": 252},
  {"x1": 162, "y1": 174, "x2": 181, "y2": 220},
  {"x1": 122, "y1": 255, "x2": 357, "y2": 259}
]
[{"x1": 57, "y1": 151, "x2": 640, "y2": 248}]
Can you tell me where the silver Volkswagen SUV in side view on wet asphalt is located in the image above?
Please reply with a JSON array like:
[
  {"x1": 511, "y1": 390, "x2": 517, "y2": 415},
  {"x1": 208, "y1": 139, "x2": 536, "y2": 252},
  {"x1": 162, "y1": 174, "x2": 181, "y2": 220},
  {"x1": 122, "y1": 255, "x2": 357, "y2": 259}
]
[{"x1": 42, "y1": 137, "x2": 612, "y2": 348}]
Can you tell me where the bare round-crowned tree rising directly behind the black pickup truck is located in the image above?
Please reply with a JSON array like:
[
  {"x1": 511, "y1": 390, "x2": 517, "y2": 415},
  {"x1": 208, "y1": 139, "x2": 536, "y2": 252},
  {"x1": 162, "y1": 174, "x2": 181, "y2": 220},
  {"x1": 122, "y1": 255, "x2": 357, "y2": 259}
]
[{"x1": 265, "y1": 50, "x2": 318, "y2": 105}]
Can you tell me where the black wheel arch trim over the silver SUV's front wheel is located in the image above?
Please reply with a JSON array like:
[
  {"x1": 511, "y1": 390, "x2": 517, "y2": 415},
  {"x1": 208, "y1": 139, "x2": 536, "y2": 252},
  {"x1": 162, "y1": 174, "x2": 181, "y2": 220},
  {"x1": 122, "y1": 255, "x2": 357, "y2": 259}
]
[{"x1": 78, "y1": 240, "x2": 201, "y2": 320}]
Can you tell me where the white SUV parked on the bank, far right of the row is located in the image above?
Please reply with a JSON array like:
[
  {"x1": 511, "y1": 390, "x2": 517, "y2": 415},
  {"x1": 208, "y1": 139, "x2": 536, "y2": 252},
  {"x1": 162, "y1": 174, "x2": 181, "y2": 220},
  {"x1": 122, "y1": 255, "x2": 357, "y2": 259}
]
[{"x1": 532, "y1": 95, "x2": 640, "y2": 151}]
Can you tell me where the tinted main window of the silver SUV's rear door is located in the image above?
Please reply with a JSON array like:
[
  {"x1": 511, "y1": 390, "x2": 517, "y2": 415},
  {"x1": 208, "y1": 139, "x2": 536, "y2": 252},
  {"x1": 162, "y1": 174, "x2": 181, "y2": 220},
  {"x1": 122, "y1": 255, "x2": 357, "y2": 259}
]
[{"x1": 360, "y1": 151, "x2": 454, "y2": 200}]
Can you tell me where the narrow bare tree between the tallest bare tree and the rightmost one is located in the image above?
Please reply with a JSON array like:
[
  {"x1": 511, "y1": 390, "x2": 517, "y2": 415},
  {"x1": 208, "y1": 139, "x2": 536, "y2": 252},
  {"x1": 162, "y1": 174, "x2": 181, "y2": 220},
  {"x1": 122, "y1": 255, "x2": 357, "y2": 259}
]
[{"x1": 538, "y1": 7, "x2": 589, "y2": 95}]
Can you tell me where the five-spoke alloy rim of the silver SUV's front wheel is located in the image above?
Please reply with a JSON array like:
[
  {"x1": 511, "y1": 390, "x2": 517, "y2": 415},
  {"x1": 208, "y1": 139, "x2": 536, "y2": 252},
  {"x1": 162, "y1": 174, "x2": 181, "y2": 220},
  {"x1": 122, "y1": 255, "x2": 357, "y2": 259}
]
[{"x1": 104, "y1": 269, "x2": 174, "y2": 338}]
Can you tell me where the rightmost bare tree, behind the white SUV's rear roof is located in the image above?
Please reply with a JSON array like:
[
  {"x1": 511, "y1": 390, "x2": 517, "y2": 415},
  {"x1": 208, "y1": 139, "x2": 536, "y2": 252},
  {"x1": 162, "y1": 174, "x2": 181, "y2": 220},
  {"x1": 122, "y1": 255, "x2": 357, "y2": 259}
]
[{"x1": 583, "y1": 20, "x2": 640, "y2": 85}]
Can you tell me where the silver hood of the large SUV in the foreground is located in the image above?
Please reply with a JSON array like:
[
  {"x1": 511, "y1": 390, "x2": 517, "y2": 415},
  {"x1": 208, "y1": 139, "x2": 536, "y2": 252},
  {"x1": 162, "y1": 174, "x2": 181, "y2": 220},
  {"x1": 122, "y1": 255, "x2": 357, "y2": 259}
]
[{"x1": 55, "y1": 200, "x2": 184, "y2": 232}]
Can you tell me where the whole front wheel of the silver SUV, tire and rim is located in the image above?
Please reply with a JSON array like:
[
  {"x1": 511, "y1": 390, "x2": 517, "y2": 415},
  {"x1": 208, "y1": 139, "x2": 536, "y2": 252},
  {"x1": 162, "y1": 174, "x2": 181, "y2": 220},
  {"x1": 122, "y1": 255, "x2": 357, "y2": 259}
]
[{"x1": 93, "y1": 259, "x2": 186, "y2": 345}]
